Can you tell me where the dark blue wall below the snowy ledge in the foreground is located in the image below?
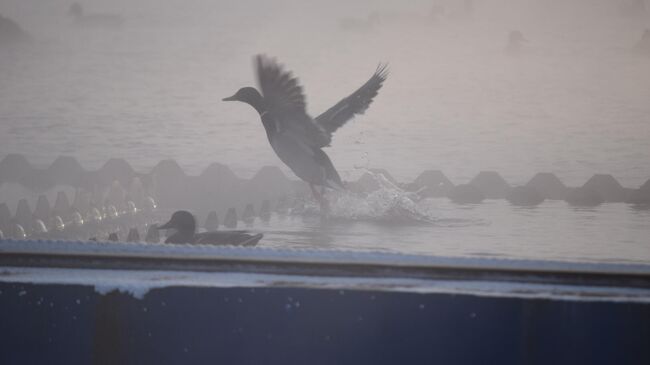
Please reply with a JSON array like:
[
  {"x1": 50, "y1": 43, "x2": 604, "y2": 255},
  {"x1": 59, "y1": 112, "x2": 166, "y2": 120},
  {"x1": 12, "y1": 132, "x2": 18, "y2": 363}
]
[{"x1": 0, "y1": 283, "x2": 650, "y2": 365}]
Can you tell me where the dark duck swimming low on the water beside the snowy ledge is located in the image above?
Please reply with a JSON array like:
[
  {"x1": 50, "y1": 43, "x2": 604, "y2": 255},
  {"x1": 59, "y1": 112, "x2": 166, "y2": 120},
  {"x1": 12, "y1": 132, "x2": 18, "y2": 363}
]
[{"x1": 158, "y1": 210, "x2": 264, "y2": 246}]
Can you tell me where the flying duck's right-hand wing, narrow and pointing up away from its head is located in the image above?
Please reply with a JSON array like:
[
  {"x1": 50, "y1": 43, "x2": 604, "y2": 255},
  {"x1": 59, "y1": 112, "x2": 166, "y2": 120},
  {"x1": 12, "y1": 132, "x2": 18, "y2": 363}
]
[{"x1": 316, "y1": 65, "x2": 388, "y2": 138}]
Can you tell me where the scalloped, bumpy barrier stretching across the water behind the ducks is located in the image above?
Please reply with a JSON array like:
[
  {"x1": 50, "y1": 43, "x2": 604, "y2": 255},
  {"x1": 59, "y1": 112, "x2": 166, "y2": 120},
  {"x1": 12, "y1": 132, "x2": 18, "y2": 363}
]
[{"x1": 0, "y1": 154, "x2": 650, "y2": 242}]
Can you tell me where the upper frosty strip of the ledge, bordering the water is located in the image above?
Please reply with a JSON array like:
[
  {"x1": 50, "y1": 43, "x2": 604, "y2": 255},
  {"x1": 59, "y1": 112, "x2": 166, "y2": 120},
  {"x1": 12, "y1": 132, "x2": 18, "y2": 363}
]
[{"x1": 0, "y1": 240, "x2": 650, "y2": 276}]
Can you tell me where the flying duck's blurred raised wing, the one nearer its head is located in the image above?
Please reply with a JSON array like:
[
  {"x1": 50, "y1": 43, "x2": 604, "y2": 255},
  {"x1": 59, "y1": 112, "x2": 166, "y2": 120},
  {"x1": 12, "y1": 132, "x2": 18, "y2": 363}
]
[{"x1": 256, "y1": 55, "x2": 331, "y2": 147}]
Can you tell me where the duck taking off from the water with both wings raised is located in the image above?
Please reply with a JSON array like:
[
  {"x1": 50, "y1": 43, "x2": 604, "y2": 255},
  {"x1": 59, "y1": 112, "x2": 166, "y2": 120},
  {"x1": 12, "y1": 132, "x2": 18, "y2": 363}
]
[{"x1": 223, "y1": 55, "x2": 388, "y2": 212}]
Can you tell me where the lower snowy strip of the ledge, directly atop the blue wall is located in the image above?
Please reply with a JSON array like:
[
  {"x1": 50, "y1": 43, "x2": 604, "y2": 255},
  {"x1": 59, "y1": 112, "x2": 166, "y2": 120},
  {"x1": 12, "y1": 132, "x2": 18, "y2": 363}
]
[{"x1": 0, "y1": 267, "x2": 650, "y2": 303}]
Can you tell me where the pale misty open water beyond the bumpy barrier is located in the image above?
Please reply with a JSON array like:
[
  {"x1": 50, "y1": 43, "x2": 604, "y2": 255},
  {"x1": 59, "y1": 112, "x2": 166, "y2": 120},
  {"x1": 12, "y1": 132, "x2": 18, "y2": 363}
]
[{"x1": 0, "y1": 0, "x2": 650, "y2": 187}]
